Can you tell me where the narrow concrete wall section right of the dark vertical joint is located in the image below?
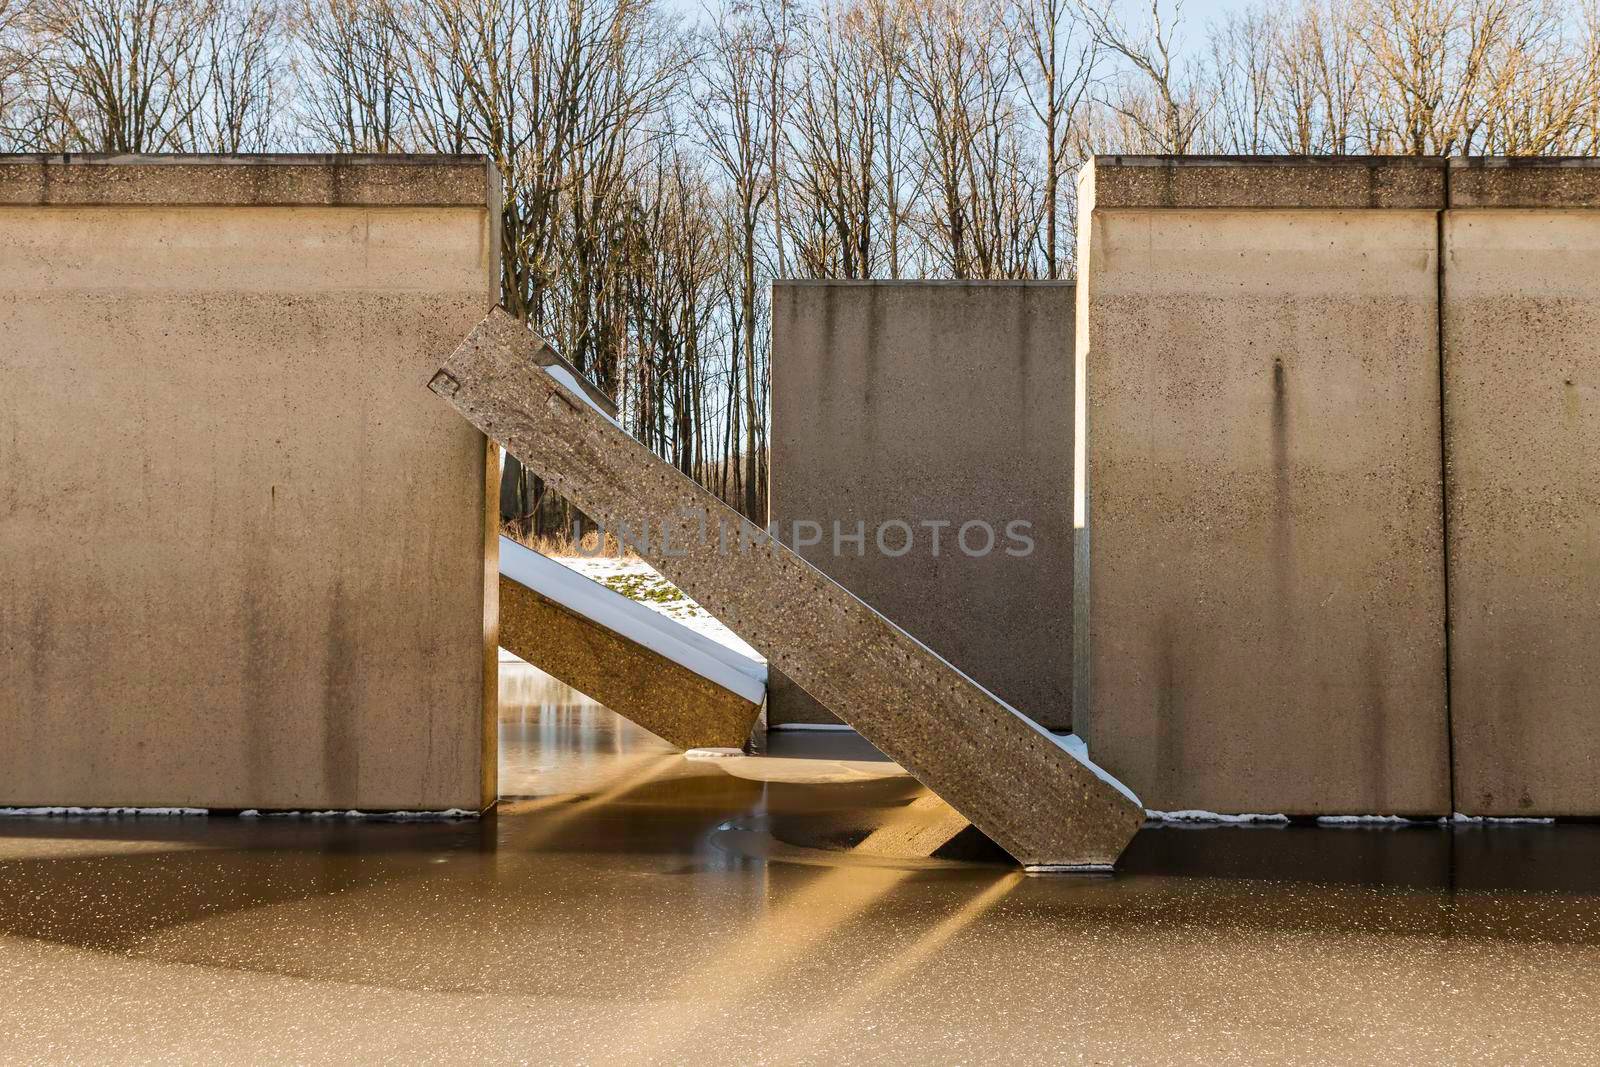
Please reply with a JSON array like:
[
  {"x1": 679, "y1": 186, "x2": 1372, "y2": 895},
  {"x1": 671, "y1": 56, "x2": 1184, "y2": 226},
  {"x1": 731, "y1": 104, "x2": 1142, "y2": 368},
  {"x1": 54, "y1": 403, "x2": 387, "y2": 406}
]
[{"x1": 1443, "y1": 160, "x2": 1600, "y2": 816}]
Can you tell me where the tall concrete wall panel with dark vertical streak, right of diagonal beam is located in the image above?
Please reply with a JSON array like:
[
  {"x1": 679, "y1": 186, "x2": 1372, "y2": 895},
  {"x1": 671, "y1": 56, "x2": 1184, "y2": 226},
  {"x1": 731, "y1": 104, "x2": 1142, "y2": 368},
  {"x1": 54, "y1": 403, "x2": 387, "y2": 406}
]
[{"x1": 1075, "y1": 151, "x2": 1450, "y2": 814}]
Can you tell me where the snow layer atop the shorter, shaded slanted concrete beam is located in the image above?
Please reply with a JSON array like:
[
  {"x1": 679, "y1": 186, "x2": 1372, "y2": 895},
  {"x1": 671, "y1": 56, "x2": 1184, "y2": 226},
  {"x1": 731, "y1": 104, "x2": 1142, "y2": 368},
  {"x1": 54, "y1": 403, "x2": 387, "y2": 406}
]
[{"x1": 499, "y1": 536, "x2": 766, "y2": 704}]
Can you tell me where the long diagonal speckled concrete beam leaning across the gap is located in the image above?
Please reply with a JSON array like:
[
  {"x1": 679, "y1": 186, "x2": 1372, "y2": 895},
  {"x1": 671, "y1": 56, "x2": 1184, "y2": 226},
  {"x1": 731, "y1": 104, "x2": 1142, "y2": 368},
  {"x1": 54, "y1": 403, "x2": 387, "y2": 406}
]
[{"x1": 430, "y1": 310, "x2": 1144, "y2": 867}]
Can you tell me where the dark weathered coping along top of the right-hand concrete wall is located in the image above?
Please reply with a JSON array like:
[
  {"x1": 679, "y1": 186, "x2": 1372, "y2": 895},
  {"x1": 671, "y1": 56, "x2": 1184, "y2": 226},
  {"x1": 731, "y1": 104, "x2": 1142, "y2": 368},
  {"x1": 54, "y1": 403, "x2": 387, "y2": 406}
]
[{"x1": 1080, "y1": 155, "x2": 1600, "y2": 211}]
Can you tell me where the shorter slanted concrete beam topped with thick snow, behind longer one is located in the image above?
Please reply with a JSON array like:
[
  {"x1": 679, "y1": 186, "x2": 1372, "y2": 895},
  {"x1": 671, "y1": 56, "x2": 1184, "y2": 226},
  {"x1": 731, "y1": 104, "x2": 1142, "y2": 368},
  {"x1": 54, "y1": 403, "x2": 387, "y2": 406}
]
[{"x1": 499, "y1": 537, "x2": 765, "y2": 749}]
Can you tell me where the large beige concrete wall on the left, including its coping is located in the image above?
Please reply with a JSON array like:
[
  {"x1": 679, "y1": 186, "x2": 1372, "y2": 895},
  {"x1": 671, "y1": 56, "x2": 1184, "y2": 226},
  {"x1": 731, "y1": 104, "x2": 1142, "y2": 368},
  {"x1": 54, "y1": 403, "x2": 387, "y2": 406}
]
[{"x1": 0, "y1": 157, "x2": 499, "y2": 808}]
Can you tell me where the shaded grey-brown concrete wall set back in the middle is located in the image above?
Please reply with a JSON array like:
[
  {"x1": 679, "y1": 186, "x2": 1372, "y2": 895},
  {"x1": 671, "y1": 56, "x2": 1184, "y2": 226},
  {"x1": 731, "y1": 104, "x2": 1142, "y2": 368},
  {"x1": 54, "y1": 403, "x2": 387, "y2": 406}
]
[{"x1": 768, "y1": 282, "x2": 1074, "y2": 729}]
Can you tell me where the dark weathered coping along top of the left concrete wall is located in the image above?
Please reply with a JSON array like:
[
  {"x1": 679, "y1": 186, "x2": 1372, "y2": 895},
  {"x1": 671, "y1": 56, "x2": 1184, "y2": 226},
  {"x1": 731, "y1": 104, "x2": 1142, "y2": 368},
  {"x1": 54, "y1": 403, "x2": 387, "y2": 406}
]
[{"x1": 0, "y1": 154, "x2": 499, "y2": 208}]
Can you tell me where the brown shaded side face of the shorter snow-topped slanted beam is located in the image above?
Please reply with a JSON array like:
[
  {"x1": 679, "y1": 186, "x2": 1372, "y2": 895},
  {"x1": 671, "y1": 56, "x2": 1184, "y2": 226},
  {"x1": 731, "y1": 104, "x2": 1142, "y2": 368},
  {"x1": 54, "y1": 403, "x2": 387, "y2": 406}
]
[{"x1": 499, "y1": 574, "x2": 762, "y2": 749}]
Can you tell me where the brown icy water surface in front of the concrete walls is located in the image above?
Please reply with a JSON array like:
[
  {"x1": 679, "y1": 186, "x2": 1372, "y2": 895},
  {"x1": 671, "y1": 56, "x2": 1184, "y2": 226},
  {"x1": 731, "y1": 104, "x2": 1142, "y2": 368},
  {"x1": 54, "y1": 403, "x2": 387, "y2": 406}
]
[{"x1": 0, "y1": 669, "x2": 1600, "y2": 1064}]
